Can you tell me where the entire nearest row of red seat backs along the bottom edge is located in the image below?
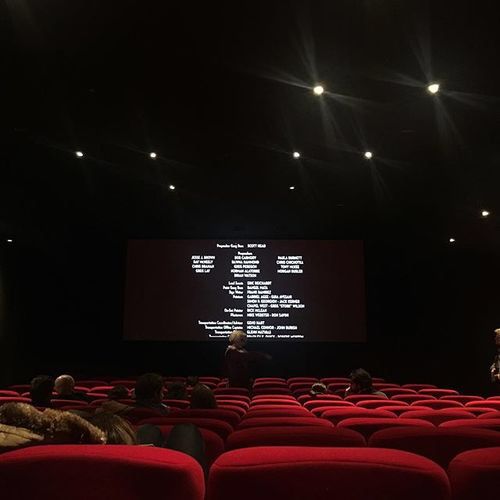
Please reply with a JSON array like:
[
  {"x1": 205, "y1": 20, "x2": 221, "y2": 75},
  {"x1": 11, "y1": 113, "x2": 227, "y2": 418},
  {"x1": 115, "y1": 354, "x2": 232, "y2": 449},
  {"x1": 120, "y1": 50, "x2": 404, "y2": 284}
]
[{"x1": 0, "y1": 445, "x2": 500, "y2": 500}]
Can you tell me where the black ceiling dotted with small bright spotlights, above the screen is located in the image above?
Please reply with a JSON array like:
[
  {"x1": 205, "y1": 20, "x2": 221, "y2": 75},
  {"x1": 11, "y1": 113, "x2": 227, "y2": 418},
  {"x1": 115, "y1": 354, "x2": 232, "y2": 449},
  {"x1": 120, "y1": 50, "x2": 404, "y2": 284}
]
[{"x1": 0, "y1": 0, "x2": 500, "y2": 246}]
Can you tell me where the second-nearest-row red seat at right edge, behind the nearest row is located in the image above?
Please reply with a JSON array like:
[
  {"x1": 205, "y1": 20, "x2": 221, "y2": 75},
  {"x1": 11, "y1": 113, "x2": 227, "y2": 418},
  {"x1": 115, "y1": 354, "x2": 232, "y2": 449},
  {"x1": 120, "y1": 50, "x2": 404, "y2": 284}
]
[{"x1": 368, "y1": 427, "x2": 500, "y2": 469}]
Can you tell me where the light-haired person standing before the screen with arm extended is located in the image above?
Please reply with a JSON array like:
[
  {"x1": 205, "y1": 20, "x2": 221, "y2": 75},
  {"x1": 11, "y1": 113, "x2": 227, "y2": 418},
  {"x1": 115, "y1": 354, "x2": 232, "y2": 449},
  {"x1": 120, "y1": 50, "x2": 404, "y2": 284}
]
[{"x1": 225, "y1": 330, "x2": 272, "y2": 389}]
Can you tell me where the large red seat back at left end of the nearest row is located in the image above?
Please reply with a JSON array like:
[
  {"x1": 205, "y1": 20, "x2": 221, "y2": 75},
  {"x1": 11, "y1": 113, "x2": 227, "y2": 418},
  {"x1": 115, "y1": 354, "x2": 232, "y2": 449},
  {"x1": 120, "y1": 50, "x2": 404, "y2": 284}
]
[{"x1": 0, "y1": 445, "x2": 205, "y2": 500}]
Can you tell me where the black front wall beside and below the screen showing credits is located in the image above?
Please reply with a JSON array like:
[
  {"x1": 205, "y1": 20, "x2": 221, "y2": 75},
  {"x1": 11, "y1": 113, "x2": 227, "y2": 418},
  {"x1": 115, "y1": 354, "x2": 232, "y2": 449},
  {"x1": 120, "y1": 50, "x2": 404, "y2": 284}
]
[{"x1": 1, "y1": 234, "x2": 500, "y2": 392}]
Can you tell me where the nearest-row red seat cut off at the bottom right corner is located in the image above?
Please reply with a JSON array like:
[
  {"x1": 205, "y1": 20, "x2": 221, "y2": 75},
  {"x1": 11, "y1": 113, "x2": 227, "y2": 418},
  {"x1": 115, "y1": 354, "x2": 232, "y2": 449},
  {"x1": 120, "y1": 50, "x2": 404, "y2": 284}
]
[{"x1": 448, "y1": 446, "x2": 500, "y2": 500}]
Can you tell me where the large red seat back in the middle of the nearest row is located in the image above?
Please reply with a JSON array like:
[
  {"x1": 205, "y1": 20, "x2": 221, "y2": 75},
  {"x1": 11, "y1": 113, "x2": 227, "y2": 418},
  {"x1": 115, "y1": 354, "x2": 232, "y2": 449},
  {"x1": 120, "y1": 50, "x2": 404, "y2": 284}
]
[{"x1": 208, "y1": 446, "x2": 450, "y2": 500}]
